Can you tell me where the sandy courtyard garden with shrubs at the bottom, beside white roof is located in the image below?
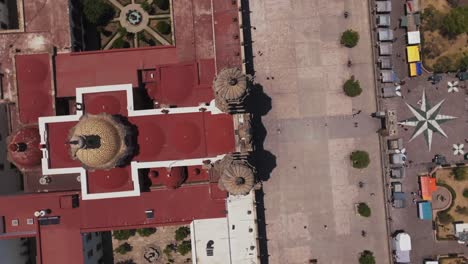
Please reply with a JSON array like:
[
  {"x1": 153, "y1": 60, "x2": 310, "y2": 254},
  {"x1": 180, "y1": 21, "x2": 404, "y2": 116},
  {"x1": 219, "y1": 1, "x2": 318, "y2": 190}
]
[{"x1": 112, "y1": 226, "x2": 192, "y2": 264}]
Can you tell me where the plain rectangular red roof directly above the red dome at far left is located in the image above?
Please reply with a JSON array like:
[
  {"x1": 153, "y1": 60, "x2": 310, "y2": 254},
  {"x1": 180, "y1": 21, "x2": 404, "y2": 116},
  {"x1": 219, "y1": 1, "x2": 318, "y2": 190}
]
[{"x1": 15, "y1": 54, "x2": 54, "y2": 124}]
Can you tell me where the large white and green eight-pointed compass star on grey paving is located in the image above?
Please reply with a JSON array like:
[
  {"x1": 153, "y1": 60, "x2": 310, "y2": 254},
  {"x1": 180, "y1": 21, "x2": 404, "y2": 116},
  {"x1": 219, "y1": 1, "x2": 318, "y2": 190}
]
[{"x1": 399, "y1": 91, "x2": 456, "y2": 150}]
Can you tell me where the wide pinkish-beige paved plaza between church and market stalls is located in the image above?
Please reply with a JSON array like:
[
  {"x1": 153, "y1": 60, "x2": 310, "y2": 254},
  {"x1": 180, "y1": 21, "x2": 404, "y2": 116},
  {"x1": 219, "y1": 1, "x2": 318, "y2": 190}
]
[{"x1": 250, "y1": 0, "x2": 389, "y2": 264}]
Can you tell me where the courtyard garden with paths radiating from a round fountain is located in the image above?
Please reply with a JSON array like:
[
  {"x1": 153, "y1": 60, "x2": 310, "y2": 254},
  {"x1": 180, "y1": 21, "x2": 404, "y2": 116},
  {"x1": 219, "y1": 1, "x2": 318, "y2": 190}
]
[{"x1": 83, "y1": 0, "x2": 174, "y2": 50}]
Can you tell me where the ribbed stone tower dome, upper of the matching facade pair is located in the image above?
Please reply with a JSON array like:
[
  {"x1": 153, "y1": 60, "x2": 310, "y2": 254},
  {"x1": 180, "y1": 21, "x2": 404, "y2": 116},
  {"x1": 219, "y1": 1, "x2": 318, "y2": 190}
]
[{"x1": 213, "y1": 68, "x2": 247, "y2": 101}]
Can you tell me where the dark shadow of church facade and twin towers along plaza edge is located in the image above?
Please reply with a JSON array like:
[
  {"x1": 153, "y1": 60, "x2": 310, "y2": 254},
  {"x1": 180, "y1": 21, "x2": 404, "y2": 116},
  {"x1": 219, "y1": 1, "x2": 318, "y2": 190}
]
[{"x1": 240, "y1": 0, "x2": 276, "y2": 264}]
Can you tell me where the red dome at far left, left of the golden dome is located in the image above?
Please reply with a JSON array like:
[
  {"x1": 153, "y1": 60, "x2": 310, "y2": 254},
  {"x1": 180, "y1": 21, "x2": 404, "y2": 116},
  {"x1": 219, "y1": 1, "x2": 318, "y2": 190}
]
[{"x1": 8, "y1": 127, "x2": 42, "y2": 168}]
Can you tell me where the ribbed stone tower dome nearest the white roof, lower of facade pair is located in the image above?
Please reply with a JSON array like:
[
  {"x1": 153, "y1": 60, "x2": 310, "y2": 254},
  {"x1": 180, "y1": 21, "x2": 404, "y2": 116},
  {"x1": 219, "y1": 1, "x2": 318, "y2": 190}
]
[{"x1": 220, "y1": 163, "x2": 255, "y2": 195}]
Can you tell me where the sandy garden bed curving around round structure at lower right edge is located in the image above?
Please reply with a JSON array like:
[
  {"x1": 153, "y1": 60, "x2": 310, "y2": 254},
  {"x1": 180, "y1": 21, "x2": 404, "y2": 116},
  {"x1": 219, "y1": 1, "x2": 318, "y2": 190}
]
[{"x1": 434, "y1": 167, "x2": 468, "y2": 240}]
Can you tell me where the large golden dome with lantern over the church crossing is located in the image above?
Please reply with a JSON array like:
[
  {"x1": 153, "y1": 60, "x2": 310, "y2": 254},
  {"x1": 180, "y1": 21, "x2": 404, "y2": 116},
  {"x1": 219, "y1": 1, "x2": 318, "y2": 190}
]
[{"x1": 69, "y1": 114, "x2": 128, "y2": 169}]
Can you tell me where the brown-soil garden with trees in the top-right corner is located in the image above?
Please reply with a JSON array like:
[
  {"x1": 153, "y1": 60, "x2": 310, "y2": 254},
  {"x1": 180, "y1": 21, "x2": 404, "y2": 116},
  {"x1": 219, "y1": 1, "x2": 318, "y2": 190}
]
[{"x1": 421, "y1": 0, "x2": 468, "y2": 73}]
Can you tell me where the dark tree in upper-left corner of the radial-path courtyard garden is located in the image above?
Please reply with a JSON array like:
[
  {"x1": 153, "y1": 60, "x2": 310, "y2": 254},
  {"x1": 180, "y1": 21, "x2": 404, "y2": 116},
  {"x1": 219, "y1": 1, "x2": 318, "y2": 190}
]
[{"x1": 83, "y1": 0, "x2": 115, "y2": 26}]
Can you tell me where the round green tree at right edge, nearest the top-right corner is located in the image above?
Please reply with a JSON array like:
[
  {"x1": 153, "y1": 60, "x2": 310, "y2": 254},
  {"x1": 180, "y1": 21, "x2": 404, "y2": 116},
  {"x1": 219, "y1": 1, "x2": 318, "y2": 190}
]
[{"x1": 441, "y1": 7, "x2": 468, "y2": 38}]
